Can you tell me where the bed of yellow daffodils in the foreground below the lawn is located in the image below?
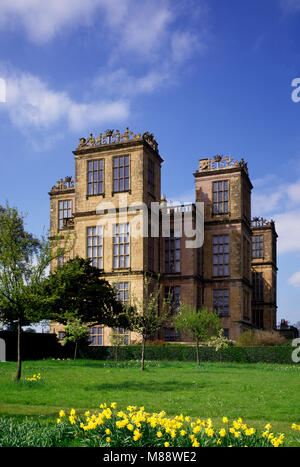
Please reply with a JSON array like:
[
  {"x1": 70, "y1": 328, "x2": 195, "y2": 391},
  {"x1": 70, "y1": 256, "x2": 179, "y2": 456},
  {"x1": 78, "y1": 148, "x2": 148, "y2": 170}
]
[{"x1": 57, "y1": 402, "x2": 290, "y2": 447}]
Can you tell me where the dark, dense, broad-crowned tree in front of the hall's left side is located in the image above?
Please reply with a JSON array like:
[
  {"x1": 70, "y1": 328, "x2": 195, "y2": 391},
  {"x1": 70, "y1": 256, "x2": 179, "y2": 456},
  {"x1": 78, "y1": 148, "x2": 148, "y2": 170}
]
[{"x1": 43, "y1": 256, "x2": 131, "y2": 328}]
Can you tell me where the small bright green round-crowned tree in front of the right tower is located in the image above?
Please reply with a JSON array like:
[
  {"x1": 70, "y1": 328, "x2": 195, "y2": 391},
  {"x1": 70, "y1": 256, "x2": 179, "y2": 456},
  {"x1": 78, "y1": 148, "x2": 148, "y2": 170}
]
[{"x1": 174, "y1": 304, "x2": 221, "y2": 365}]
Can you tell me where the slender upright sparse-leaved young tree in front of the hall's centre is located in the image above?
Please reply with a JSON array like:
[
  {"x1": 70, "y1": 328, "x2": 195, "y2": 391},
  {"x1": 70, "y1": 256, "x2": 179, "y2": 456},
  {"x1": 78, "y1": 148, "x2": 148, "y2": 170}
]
[{"x1": 129, "y1": 276, "x2": 169, "y2": 371}]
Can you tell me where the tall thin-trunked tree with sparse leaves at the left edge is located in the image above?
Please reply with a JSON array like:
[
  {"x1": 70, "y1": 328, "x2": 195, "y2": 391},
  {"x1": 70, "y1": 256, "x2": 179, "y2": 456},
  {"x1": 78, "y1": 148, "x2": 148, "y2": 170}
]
[{"x1": 0, "y1": 203, "x2": 68, "y2": 381}]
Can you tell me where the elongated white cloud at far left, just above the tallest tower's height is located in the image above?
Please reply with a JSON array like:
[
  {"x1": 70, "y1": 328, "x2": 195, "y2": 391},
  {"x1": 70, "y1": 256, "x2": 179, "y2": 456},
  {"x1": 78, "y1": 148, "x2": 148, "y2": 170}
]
[{"x1": 3, "y1": 73, "x2": 129, "y2": 131}]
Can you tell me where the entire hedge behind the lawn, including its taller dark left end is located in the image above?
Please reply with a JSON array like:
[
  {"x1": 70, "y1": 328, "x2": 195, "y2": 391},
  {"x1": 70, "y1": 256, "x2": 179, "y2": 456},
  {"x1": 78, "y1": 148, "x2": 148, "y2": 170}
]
[{"x1": 0, "y1": 331, "x2": 295, "y2": 364}]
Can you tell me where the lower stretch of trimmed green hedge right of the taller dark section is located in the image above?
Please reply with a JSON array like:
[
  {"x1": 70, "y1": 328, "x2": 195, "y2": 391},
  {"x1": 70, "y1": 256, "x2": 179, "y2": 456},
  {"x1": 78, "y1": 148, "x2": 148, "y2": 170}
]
[{"x1": 75, "y1": 344, "x2": 294, "y2": 364}]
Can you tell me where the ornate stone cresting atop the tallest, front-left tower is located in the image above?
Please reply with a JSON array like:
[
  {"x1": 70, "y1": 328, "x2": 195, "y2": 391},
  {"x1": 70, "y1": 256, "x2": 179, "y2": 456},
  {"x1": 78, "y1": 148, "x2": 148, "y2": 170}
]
[{"x1": 77, "y1": 127, "x2": 158, "y2": 152}]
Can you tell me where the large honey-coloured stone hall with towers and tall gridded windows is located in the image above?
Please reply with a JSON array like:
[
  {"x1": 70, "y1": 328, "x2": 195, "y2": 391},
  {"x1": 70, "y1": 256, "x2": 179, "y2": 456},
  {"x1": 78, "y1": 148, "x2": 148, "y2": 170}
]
[{"x1": 49, "y1": 128, "x2": 277, "y2": 345}]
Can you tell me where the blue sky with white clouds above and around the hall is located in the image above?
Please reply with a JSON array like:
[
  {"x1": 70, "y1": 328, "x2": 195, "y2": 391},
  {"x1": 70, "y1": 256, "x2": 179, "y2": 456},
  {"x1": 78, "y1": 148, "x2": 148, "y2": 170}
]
[{"x1": 0, "y1": 0, "x2": 300, "y2": 323}]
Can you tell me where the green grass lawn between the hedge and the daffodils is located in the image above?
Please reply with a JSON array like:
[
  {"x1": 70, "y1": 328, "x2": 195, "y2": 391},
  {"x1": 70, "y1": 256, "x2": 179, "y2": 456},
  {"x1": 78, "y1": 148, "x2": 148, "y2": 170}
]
[{"x1": 0, "y1": 360, "x2": 300, "y2": 445}]
